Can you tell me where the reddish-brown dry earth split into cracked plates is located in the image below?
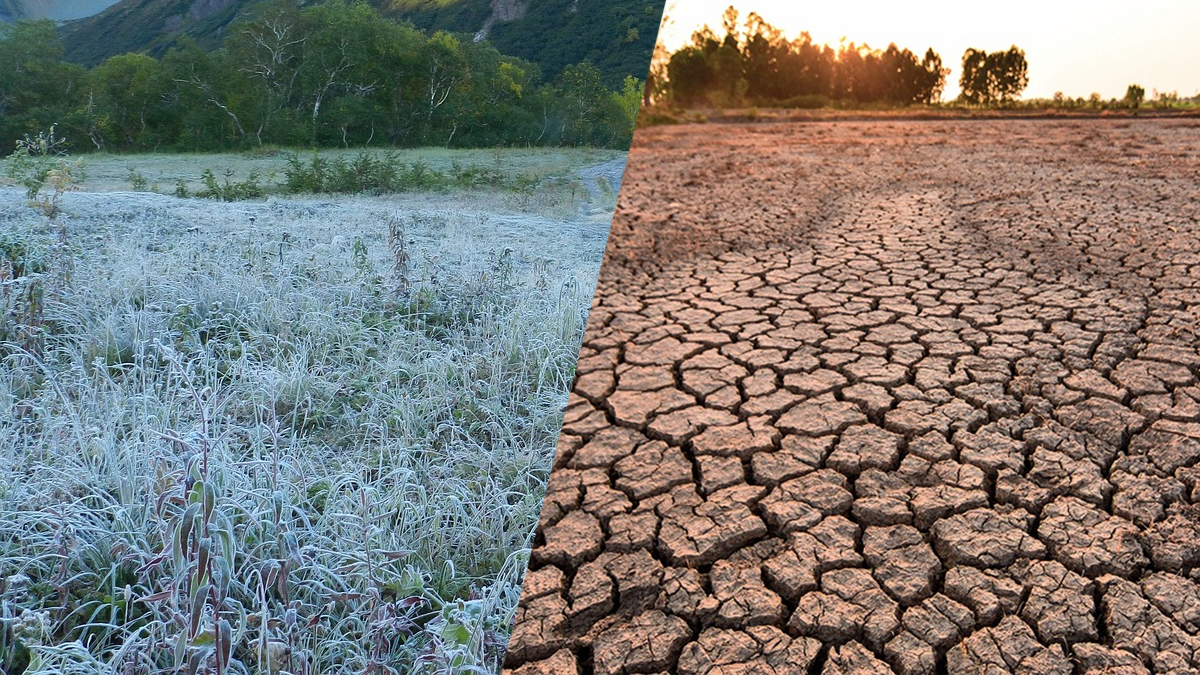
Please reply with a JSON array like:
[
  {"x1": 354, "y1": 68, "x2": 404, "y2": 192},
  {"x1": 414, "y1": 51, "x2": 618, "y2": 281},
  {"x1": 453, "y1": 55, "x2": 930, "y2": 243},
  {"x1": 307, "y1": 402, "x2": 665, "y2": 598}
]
[{"x1": 508, "y1": 119, "x2": 1200, "y2": 675}]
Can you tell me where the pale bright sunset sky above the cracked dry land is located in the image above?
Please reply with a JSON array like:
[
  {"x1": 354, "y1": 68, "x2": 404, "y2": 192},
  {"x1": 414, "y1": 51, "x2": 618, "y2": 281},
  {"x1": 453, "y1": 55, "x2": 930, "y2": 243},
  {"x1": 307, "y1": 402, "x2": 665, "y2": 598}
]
[{"x1": 660, "y1": 0, "x2": 1200, "y2": 101}]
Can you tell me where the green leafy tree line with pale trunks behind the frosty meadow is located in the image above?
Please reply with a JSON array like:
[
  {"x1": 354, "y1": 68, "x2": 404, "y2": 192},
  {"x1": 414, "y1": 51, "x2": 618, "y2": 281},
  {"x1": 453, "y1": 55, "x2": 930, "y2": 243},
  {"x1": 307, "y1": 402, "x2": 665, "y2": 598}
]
[{"x1": 0, "y1": 0, "x2": 642, "y2": 151}]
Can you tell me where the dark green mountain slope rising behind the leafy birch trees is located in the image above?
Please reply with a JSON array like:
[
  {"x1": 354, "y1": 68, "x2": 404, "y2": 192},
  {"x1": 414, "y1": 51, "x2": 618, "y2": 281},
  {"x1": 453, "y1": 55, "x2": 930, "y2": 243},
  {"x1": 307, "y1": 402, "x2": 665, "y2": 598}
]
[{"x1": 60, "y1": 0, "x2": 662, "y2": 85}]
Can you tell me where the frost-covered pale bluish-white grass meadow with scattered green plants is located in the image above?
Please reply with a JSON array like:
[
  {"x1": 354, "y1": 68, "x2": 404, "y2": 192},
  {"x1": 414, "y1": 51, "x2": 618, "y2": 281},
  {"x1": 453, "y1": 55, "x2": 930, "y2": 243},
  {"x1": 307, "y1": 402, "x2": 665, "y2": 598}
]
[{"x1": 0, "y1": 173, "x2": 608, "y2": 674}]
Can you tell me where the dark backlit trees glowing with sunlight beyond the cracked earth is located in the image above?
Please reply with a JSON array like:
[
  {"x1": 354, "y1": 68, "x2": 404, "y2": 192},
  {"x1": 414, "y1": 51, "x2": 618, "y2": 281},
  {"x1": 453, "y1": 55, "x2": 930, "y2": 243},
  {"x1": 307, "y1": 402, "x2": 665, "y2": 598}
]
[{"x1": 648, "y1": 7, "x2": 1028, "y2": 108}]
